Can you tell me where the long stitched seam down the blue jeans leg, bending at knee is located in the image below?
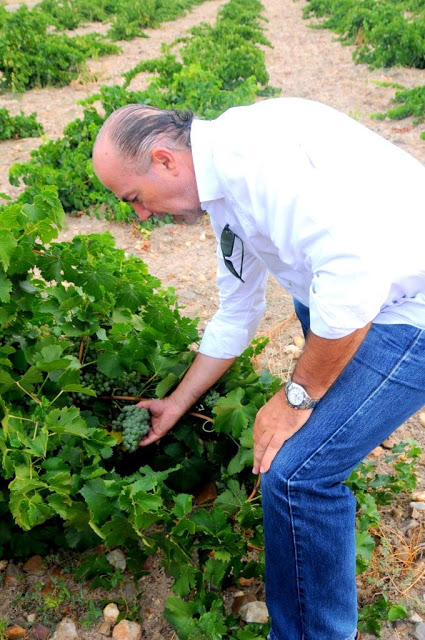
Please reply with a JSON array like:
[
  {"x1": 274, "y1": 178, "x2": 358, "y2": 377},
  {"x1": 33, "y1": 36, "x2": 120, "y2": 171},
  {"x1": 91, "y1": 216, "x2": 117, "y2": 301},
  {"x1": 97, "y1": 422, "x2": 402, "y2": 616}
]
[{"x1": 287, "y1": 329, "x2": 424, "y2": 640}]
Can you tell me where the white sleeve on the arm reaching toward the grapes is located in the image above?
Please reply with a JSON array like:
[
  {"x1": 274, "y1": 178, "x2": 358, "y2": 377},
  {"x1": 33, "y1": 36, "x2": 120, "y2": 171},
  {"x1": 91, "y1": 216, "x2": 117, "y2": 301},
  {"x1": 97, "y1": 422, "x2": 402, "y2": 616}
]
[{"x1": 199, "y1": 220, "x2": 267, "y2": 359}]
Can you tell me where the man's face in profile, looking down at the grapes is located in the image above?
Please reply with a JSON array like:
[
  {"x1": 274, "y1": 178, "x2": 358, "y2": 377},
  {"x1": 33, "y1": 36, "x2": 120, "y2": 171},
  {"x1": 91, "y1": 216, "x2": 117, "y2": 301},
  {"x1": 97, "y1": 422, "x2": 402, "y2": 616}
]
[{"x1": 93, "y1": 139, "x2": 205, "y2": 224}]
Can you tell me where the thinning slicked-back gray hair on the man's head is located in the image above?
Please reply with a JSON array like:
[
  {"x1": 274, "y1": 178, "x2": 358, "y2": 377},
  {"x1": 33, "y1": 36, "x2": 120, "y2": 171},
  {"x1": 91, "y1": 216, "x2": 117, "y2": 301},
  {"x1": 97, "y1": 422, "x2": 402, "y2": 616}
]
[{"x1": 93, "y1": 104, "x2": 193, "y2": 173}]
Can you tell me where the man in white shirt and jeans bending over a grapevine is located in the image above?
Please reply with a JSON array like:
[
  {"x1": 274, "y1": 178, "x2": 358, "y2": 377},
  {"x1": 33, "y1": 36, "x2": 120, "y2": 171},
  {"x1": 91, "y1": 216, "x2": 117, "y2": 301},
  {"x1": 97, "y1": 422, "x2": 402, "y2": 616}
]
[{"x1": 93, "y1": 98, "x2": 425, "y2": 640}]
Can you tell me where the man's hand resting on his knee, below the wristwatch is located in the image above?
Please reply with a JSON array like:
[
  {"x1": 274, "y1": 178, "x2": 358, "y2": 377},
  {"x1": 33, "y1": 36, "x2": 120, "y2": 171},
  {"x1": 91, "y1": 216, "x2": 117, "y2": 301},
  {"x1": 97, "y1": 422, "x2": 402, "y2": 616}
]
[{"x1": 252, "y1": 389, "x2": 312, "y2": 474}]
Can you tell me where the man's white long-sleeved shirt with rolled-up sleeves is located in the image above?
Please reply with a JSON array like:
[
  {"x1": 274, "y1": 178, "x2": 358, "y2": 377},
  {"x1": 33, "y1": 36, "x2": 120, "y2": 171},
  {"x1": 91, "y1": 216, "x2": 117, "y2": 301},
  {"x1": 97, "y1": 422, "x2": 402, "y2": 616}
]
[{"x1": 191, "y1": 98, "x2": 425, "y2": 358}]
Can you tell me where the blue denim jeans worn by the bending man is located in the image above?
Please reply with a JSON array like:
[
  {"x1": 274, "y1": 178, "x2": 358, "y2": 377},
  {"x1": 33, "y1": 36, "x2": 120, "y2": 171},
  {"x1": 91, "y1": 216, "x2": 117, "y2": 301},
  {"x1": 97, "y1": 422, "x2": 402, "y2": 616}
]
[{"x1": 261, "y1": 303, "x2": 425, "y2": 640}]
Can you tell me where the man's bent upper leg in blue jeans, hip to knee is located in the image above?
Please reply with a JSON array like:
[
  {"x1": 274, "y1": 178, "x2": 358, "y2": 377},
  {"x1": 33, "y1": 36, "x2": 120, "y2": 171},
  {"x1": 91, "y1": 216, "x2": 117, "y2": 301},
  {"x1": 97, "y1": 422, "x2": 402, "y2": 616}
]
[{"x1": 272, "y1": 325, "x2": 425, "y2": 483}]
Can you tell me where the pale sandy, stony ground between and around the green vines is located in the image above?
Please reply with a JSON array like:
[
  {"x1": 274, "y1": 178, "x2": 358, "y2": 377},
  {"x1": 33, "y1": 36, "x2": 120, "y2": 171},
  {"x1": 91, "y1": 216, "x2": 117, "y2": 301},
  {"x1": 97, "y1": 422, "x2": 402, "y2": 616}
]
[{"x1": 0, "y1": 0, "x2": 425, "y2": 640}]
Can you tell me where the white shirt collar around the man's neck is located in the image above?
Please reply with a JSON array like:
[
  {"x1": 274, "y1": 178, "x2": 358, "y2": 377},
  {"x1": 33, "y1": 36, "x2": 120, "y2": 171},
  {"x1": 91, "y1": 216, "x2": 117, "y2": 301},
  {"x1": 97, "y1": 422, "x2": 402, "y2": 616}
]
[{"x1": 190, "y1": 119, "x2": 223, "y2": 204}]
